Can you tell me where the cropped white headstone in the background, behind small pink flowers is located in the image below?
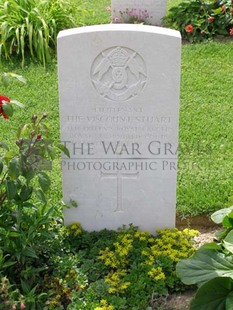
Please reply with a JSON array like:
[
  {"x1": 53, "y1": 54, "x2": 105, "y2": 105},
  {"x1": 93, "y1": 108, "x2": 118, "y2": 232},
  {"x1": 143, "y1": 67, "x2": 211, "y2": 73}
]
[{"x1": 111, "y1": 0, "x2": 167, "y2": 26}]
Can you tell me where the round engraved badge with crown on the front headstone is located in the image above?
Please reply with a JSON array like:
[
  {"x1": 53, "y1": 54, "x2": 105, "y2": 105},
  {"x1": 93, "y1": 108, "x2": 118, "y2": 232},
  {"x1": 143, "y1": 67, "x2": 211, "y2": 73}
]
[{"x1": 91, "y1": 46, "x2": 147, "y2": 101}]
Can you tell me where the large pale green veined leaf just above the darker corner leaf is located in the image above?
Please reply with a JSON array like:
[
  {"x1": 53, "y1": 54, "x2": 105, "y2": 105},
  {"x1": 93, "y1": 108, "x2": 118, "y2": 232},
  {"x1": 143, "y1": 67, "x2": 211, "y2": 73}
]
[{"x1": 176, "y1": 248, "x2": 233, "y2": 285}]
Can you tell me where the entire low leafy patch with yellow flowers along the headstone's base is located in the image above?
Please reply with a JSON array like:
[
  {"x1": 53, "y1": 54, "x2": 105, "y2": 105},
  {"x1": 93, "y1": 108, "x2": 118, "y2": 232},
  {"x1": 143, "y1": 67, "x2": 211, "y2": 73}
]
[{"x1": 62, "y1": 223, "x2": 197, "y2": 310}]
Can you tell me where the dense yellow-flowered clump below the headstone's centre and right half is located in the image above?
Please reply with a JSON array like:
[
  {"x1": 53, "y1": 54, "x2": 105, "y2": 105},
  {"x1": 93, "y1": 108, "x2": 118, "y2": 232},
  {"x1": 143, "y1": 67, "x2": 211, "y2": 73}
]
[{"x1": 96, "y1": 226, "x2": 198, "y2": 309}]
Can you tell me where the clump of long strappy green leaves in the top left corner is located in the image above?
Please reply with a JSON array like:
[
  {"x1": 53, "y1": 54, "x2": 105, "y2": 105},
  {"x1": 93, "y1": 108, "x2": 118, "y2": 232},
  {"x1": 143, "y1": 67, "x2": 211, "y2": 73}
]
[{"x1": 0, "y1": 0, "x2": 85, "y2": 65}]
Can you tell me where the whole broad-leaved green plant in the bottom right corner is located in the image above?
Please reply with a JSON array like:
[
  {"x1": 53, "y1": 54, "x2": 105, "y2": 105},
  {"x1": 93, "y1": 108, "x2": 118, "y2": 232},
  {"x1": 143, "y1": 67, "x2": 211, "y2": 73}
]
[{"x1": 176, "y1": 207, "x2": 233, "y2": 310}]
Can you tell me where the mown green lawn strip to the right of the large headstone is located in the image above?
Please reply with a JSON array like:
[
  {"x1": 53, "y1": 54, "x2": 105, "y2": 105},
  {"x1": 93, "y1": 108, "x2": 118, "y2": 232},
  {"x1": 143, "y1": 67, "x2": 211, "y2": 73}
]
[{"x1": 177, "y1": 41, "x2": 233, "y2": 214}]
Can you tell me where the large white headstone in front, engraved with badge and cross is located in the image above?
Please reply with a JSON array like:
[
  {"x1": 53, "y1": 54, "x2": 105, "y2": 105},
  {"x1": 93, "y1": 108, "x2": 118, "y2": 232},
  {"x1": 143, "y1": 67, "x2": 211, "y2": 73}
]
[{"x1": 58, "y1": 24, "x2": 181, "y2": 232}]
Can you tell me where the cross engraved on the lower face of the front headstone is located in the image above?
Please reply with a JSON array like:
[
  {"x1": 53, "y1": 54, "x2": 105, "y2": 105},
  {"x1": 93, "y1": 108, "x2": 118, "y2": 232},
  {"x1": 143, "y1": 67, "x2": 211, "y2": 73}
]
[{"x1": 101, "y1": 171, "x2": 139, "y2": 212}]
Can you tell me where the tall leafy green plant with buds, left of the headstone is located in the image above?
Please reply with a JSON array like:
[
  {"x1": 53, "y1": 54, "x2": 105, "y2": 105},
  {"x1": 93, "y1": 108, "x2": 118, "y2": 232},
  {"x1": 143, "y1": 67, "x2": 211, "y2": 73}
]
[{"x1": 0, "y1": 114, "x2": 69, "y2": 309}]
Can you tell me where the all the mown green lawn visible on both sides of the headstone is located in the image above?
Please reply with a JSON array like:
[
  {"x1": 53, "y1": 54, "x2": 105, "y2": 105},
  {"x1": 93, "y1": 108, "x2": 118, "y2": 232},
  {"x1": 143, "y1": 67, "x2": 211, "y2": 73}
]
[{"x1": 0, "y1": 0, "x2": 233, "y2": 216}]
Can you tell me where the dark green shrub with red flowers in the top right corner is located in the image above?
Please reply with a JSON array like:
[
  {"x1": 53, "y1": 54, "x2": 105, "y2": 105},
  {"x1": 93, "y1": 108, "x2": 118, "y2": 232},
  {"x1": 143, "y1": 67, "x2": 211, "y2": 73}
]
[{"x1": 165, "y1": 0, "x2": 233, "y2": 42}]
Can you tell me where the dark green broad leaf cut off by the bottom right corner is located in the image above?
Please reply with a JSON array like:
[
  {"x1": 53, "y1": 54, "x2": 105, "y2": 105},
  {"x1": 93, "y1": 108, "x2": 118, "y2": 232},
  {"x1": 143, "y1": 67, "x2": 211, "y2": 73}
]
[{"x1": 190, "y1": 277, "x2": 233, "y2": 310}]
